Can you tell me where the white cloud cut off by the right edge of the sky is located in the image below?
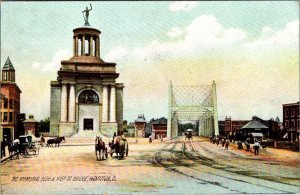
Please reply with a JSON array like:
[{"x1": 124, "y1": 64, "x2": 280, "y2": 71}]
[{"x1": 246, "y1": 20, "x2": 299, "y2": 49}]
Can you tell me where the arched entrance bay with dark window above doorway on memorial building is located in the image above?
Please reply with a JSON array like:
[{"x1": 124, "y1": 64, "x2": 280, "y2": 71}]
[{"x1": 77, "y1": 89, "x2": 100, "y2": 131}]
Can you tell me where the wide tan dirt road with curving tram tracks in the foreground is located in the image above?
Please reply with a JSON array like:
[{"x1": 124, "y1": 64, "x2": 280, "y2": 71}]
[{"x1": 1, "y1": 137, "x2": 300, "y2": 194}]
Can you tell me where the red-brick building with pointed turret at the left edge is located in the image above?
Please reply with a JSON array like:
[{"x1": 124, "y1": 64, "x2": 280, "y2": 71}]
[{"x1": 0, "y1": 57, "x2": 22, "y2": 141}]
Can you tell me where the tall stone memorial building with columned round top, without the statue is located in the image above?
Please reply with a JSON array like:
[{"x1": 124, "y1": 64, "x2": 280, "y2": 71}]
[{"x1": 50, "y1": 21, "x2": 124, "y2": 136}]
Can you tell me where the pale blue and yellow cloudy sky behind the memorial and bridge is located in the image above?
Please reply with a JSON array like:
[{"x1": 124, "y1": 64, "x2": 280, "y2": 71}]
[{"x1": 1, "y1": 1, "x2": 299, "y2": 121}]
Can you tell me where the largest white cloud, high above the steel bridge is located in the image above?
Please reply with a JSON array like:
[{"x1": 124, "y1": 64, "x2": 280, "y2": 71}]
[{"x1": 133, "y1": 15, "x2": 247, "y2": 60}]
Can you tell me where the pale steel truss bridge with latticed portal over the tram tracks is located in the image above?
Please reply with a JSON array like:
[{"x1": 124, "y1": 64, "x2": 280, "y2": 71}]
[{"x1": 167, "y1": 81, "x2": 219, "y2": 138}]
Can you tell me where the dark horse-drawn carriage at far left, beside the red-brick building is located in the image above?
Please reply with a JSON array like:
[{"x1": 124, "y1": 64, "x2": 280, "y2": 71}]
[{"x1": 19, "y1": 135, "x2": 39, "y2": 156}]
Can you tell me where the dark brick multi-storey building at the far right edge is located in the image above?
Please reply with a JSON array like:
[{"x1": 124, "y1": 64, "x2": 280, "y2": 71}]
[{"x1": 282, "y1": 102, "x2": 300, "y2": 141}]
